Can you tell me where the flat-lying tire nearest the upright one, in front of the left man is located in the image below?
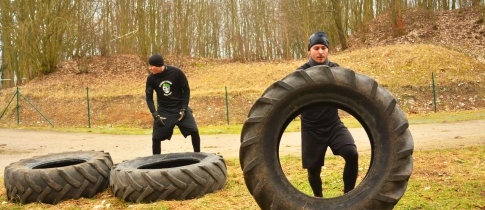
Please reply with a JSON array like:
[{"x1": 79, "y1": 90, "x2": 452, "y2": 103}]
[{"x1": 110, "y1": 152, "x2": 227, "y2": 203}]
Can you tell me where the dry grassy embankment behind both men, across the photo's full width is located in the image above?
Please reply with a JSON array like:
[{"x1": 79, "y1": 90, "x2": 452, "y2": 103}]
[{"x1": 0, "y1": 45, "x2": 485, "y2": 128}]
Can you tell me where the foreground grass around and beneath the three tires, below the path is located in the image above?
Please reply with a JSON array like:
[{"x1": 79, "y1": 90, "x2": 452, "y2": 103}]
[{"x1": 0, "y1": 146, "x2": 485, "y2": 209}]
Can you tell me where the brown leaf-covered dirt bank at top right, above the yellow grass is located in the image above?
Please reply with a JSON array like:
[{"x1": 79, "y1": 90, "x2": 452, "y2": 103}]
[{"x1": 348, "y1": 6, "x2": 485, "y2": 63}]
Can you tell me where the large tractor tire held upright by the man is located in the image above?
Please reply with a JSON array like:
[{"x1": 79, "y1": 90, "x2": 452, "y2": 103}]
[{"x1": 239, "y1": 66, "x2": 414, "y2": 209}]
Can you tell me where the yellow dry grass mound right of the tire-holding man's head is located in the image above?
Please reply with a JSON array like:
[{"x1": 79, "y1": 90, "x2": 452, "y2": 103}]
[{"x1": 335, "y1": 45, "x2": 485, "y2": 87}]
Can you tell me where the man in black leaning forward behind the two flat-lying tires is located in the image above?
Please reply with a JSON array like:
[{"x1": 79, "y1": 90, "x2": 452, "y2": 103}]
[{"x1": 145, "y1": 54, "x2": 200, "y2": 155}]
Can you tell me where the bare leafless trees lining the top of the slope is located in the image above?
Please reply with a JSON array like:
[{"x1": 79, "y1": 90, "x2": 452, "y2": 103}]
[{"x1": 0, "y1": 0, "x2": 485, "y2": 87}]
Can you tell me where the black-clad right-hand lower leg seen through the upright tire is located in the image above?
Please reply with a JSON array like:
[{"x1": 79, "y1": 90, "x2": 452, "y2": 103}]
[{"x1": 339, "y1": 144, "x2": 359, "y2": 193}]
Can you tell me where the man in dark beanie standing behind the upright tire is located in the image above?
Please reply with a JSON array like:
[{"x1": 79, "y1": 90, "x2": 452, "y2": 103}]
[{"x1": 297, "y1": 32, "x2": 359, "y2": 197}]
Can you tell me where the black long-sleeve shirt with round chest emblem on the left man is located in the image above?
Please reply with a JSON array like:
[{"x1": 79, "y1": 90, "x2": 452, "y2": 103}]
[{"x1": 145, "y1": 66, "x2": 190, "y2": 114}]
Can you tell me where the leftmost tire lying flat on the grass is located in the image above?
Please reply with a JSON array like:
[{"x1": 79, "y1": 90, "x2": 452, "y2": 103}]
[{"x1": 4, "y1": 151, "x2": 113, "y2": 204}]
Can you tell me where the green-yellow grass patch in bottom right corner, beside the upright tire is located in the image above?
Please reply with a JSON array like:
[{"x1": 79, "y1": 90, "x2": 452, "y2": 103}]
[{"x1": 396, "y1": 146, "x2": 485, "y2": 209}]
